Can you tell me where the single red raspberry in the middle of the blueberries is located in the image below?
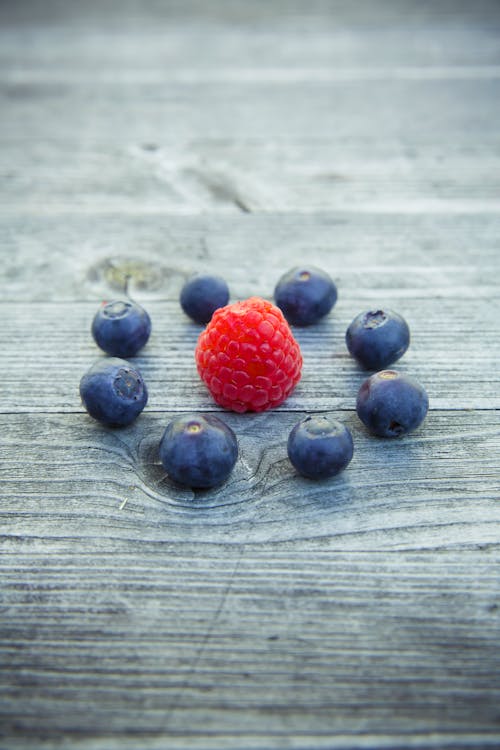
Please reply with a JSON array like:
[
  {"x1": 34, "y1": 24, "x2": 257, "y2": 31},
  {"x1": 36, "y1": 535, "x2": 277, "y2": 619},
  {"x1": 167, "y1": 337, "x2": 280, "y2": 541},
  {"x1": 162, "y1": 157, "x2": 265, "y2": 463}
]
[{"x1": 195, "y1": 297, "x2": 302, "y2": 412}]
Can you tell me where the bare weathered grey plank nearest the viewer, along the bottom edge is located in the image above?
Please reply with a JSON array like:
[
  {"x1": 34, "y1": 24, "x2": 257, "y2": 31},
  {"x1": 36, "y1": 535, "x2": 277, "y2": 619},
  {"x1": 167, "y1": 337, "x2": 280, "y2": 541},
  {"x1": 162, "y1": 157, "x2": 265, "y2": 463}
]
[{"x1": 0, "y1": 540, "x2": 500, "y2": 748}]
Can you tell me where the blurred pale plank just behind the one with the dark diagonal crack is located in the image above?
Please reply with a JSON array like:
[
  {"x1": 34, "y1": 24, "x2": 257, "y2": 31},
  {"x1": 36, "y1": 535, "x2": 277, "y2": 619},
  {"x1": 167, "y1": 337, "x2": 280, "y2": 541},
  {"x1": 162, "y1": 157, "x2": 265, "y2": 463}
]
[{"x1": 0, "y1": 78, "x2": 499, "y2": 144}]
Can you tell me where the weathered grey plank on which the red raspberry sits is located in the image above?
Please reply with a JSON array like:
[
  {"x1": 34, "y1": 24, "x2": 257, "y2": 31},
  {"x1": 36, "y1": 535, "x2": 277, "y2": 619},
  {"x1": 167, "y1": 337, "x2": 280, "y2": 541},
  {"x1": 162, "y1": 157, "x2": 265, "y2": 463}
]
[{"x1": 0, "y1": 292, "x2": 500, "y2": 413}]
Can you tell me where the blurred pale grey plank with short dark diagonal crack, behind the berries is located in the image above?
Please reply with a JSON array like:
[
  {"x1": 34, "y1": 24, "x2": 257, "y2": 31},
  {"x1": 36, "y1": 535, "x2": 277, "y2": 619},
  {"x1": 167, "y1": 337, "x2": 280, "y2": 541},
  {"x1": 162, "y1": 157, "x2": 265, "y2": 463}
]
[{"x1": 0, "y1": 138, "x2": 500, "y2": 217}]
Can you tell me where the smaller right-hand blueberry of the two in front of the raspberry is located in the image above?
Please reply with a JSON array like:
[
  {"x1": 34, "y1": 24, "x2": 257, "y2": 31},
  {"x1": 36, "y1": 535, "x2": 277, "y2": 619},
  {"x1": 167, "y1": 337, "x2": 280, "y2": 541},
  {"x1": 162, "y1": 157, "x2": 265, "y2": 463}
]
[{"x1": 287, "y1": 414, "x2": 354, "y2": 479}]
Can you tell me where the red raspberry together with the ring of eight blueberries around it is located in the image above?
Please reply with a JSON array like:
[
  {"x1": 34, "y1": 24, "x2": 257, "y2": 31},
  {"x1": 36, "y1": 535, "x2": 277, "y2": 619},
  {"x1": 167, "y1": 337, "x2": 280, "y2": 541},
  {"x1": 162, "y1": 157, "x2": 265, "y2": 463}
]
[{"x1": 80, "y1": 266, "x2": 429, "y2": 489}]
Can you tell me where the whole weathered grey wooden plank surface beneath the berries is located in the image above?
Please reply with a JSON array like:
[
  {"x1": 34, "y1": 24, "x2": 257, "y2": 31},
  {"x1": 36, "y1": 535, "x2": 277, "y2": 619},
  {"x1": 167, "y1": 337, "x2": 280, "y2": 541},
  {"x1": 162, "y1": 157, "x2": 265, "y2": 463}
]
[{"x1": 0, "y1": 0, "x2": 500, "y2": 750}]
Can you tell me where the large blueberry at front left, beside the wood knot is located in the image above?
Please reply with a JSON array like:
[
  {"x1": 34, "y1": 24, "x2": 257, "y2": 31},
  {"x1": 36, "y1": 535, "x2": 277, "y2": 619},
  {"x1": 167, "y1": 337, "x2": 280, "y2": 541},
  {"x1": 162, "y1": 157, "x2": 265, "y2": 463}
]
[{"x1": 160, "y1": 414, "x2": 238, "y2": 489}]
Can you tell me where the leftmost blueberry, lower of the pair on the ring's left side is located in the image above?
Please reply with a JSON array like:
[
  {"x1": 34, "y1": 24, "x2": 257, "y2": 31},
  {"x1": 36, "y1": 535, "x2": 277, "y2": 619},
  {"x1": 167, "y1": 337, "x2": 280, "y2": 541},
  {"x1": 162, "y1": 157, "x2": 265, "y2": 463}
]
[{"x1": 80, "y1": 357, "x2": 148, "y2": 427}]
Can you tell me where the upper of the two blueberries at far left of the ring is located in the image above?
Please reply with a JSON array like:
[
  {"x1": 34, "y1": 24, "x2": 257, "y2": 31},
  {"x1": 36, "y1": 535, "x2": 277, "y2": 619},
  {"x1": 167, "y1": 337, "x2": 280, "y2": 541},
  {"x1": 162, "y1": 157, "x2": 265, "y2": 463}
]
[{"x1": 92, "y1": 300, "x2": 151, "y2": 357}]
